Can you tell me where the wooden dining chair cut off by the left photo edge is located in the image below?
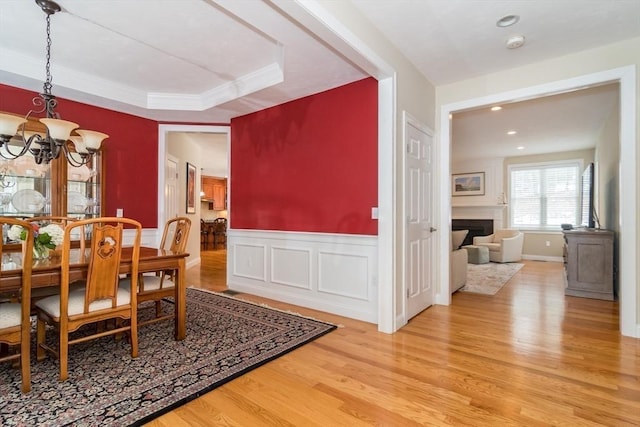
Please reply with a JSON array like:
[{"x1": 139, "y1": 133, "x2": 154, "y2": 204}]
[{"x1": 0, "y1": 217, "x2": 33, "y2": 393}]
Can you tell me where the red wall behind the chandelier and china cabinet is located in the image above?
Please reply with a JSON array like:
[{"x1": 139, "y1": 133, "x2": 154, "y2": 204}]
[{"x1": 0, "y1": 84, "x2": 158, "y2": 228}]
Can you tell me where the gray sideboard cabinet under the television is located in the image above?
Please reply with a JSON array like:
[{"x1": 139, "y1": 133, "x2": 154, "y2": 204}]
[{"x1": 564, "y1": 230, "x2": 615, "y2": 300}]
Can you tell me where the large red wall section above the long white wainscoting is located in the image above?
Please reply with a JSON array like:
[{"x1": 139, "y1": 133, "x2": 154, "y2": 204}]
[{"x1": 230, "y1": 78, "x2": 378, "y2": 235}]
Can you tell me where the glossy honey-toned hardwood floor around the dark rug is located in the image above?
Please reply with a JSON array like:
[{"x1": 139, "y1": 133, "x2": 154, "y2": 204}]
[{"x1": 148, "y1": 251, "x2": 640, "y2": 427}]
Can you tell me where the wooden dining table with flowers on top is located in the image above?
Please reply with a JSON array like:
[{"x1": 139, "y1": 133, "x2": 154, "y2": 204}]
[{"x1": 0, "y1": 246, "x2": 189, "y2": 340}]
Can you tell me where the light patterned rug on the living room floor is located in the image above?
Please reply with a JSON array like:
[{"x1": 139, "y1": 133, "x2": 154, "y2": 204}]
[{"x1": 460, "y1": 262, "x2": 524, "y2": 295}]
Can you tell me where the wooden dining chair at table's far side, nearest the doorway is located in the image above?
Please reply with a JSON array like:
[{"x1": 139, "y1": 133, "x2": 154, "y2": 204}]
[{"x1": 120, "y1": 217, "x2": 191, "y2": 326}]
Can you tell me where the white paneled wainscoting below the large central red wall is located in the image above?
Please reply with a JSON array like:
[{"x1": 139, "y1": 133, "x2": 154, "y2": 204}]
[{"x1": 227, "y1": 229, "x2": 378, "y2": 323}]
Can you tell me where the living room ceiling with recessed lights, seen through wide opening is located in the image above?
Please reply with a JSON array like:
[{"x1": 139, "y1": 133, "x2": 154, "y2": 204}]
[{"x1": 451, "y1": 83, "x2": 619, "y2": 163}]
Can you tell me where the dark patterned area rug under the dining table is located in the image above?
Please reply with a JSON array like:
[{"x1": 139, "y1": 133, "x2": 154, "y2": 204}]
[{"x1": 0, "y1": 289, "x2": 335, "y2": 426}]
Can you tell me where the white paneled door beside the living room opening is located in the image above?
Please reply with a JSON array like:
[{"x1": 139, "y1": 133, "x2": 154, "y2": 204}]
[{"x1": 405, "y1": 119, "x2": 435, "y2": 320}]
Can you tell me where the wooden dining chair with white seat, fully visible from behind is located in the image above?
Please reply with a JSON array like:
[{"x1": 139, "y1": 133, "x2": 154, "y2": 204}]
[{"x1": 36, "y1": 217, "x2": 142, "y2": 381}]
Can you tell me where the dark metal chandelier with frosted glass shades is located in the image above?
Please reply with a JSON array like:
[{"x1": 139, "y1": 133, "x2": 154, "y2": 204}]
[{"x1": 0, "y1": 0, "x2": 109, "y2": 167}]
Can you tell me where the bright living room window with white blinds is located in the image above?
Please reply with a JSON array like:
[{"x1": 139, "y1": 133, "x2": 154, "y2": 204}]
[{"x1": 509, "y1": 160, "x2": 581, "y2": 230}]
